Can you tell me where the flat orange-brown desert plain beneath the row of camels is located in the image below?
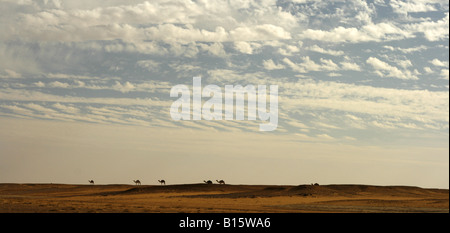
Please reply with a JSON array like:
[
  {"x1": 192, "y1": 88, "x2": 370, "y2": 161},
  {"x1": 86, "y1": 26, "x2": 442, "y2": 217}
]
[{"x1": 0, "y1": 183, "x2": 449, "y2": 213}]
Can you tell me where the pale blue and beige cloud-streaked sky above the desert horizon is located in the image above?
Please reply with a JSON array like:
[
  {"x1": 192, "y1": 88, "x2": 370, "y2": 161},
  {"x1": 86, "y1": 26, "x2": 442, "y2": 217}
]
[{"x1": 0, "y1": 0, "x2": 449, "y2": 189}]
